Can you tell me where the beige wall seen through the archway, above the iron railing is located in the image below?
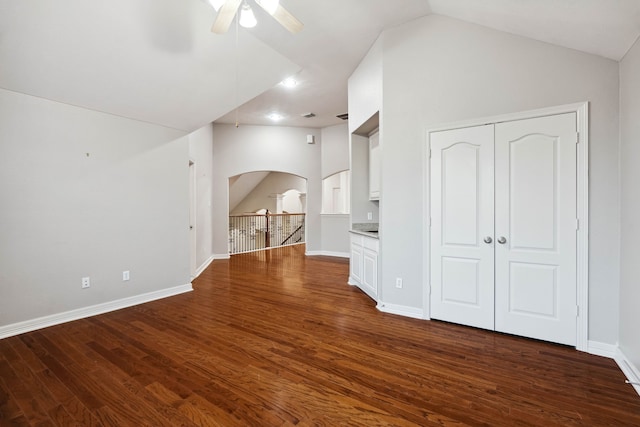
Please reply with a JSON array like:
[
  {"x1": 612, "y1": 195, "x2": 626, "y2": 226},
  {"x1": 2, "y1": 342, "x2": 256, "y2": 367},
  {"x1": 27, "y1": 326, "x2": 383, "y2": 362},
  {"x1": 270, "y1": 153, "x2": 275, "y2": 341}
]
[{"x1": 232, "y1": 172, "x2": 307, "y2": 215}]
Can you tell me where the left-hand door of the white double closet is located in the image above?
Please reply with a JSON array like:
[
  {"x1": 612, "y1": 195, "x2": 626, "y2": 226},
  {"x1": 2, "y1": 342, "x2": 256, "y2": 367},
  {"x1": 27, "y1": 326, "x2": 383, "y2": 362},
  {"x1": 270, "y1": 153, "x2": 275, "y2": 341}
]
[{"x1": 431, "y1": 125, "x2": 494, "y2": 329}]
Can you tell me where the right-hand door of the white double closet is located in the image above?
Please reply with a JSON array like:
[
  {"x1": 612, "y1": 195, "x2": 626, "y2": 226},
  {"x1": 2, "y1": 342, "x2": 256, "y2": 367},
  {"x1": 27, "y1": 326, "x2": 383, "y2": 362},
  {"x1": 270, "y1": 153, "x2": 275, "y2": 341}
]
[{"x1": 495, "y1": 113, "x2": 577, "y2": 345}]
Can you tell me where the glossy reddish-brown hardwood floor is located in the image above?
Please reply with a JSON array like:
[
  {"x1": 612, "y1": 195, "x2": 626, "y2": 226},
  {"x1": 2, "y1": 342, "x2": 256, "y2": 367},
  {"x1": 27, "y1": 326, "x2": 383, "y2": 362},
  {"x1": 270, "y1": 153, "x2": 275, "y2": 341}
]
[{"x1": 0, "y1": 246, "x2": 640, "y2": 426}]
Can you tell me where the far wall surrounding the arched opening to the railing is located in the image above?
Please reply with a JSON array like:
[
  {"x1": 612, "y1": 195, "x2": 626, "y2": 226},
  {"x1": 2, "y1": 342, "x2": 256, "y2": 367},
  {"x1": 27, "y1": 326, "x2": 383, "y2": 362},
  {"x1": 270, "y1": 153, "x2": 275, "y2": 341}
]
[{"x1": 212, "y1": 124, "x2": 322, "y2": 258}]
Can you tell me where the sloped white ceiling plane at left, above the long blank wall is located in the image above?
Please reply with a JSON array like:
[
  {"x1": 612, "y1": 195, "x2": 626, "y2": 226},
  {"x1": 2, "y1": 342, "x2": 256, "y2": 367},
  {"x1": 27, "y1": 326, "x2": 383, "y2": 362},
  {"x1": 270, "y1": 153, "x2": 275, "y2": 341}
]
[{"x1": 0, "y1": 0, "x2": 299, "y2": 132}]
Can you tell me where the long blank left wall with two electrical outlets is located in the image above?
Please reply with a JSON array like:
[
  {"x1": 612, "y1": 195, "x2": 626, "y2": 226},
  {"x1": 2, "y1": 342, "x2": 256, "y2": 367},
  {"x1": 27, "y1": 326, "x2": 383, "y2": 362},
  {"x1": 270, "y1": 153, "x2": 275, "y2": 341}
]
[{"x1": 0, "y1": 89, "x2": 189, "y2": 328}]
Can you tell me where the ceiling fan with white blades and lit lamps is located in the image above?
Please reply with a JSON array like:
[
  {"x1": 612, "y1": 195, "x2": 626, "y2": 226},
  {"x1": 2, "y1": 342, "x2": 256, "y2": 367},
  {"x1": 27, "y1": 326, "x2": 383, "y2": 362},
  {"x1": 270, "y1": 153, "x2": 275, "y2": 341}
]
[{"x1": 209, "y1": 0, "x2": 304, "y2": 34}]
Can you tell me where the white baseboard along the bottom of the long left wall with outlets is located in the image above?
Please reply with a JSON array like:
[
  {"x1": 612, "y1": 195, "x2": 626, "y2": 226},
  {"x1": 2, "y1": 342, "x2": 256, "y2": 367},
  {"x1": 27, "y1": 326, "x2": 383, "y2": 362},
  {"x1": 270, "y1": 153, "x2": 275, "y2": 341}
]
[{"x1": 0, "y1": 283, "x2": 193, "y2": 339}]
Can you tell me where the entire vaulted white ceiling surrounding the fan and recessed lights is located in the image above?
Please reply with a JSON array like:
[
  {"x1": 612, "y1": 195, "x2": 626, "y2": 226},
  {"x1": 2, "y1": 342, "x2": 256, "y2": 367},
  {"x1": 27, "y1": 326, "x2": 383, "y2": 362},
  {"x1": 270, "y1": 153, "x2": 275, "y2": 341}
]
[{"x1": 0, "y1": 0, "x2": 640, "y2": 131}]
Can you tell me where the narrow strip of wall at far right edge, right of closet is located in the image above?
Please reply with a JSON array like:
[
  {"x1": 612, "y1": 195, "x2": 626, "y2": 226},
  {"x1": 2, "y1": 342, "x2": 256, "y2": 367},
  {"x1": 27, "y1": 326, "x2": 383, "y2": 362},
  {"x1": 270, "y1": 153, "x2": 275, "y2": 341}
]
[{"x1": 620, "y1": 41, "x2": 640, "y2": 370}]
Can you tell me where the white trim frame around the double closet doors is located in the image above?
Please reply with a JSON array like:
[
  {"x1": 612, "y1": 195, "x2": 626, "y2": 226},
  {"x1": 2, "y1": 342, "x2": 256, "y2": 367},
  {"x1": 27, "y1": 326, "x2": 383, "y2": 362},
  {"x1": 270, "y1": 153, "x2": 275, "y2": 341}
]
[{"x1": 422, "y1": 102, "x2": 589, "y2": 352}]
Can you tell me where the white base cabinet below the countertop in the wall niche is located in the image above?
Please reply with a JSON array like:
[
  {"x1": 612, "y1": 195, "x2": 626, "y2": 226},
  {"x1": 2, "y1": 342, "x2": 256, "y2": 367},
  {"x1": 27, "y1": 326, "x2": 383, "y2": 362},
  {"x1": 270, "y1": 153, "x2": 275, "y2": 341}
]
[{"x1": 349, "y1": 234, "x2": 379, "y2": 301}]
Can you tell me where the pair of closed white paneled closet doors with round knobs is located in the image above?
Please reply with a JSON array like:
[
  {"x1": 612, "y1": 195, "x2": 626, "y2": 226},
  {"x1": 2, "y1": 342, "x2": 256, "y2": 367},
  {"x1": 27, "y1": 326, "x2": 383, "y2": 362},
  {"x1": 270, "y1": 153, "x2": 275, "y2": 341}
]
[{"x1": 430, "y1": 113, "x2": 578, "y2": 345}]
